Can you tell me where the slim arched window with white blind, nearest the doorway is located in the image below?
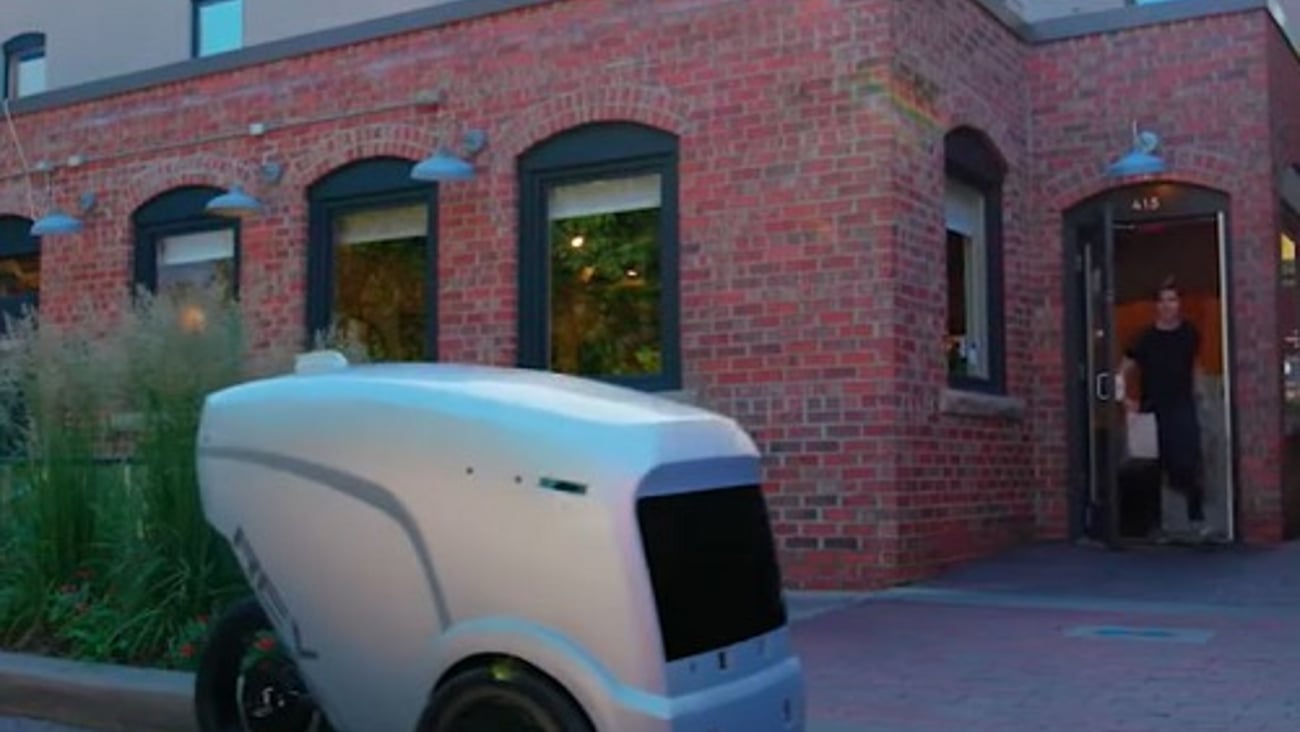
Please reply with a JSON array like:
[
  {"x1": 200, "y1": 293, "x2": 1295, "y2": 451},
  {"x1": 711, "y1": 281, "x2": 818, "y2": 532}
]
[{"x1": 944, "y1": 127, "x2": 1005, "y2": 391}]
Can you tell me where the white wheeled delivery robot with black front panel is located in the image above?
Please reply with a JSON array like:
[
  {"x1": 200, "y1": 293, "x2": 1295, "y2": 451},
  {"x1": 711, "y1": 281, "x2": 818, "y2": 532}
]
[{"x1": 195, "y1": 351, "x2": 805, "y2": 732}]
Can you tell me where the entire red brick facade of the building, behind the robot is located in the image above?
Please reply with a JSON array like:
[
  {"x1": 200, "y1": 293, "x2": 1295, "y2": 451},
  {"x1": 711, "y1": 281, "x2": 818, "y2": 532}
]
[{"x1": 0, "y1": 0, "x2": 1278, "y2": 586}]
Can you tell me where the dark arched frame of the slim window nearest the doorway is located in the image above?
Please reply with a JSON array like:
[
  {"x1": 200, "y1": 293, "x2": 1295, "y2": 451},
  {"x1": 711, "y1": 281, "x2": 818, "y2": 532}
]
[{"x1": 944, "y1": 127, "x2": 1006, "y2": 394}]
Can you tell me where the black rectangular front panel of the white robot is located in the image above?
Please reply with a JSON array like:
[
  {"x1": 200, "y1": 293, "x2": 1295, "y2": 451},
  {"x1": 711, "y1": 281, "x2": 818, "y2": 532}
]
[{"x1": 637, "y1": 485, "x2": 785, "y2": 662}]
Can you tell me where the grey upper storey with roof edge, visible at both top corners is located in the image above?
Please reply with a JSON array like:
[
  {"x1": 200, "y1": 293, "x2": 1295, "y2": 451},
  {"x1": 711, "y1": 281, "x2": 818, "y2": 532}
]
[{"x1": 0, "y1": 0, "x2": 1300, "y2": 113}]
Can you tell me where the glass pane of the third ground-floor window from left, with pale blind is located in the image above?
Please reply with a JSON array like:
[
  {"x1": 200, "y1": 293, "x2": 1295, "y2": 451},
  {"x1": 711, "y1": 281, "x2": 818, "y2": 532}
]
[{"x1": 333, "y1": 203, "x2": 429, "y2": 361}]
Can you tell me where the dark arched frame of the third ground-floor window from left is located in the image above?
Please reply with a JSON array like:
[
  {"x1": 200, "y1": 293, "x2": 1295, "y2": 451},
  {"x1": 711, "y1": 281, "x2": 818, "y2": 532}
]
[{"x1": 306, "y1": 156, "x2": 441, "y2": 361}]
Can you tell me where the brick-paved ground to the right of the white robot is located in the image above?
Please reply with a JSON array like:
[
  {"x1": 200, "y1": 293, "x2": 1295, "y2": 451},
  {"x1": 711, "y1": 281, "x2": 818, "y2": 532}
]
[{"x1": 0, "y1": 543, "x2": 1300, "y2": 732}]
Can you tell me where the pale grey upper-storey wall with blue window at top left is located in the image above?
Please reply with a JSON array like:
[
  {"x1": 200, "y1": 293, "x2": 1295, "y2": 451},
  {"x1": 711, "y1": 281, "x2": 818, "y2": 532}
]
[{"x1": 0, "y1": 0, "x2": 460, "y2": 98}]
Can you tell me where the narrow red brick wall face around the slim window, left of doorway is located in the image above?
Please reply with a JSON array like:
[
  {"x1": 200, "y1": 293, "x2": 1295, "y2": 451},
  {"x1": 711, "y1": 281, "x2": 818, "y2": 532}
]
[{"x1": 891, "y1": 0, "x2": 1047, "y2": 579}]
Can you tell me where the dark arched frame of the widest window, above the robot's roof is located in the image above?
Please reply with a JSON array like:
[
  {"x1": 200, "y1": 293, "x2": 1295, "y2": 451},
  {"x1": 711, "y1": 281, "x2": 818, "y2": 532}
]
[{"x1": 516, "y1": 122, "x2": 683, "y2": 391}]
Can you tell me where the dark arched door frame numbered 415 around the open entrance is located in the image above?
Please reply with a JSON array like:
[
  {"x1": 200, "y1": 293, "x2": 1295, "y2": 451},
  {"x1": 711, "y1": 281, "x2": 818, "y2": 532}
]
[{"x1": 1061, "y1": 181, "x2": 1242, "y2": 543}]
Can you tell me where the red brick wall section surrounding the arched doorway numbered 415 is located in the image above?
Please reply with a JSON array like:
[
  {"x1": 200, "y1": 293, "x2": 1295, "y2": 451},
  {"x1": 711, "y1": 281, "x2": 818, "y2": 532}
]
[{"x1": 1030, "y1": 12, "x2": 1294, "y2": 541}]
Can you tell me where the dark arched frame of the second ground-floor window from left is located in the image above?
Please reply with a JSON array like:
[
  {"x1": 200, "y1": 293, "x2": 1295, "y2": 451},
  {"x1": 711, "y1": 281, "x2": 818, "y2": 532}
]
[{"x1": 131, "y1": 186, "x2": 243, "y2": 302}]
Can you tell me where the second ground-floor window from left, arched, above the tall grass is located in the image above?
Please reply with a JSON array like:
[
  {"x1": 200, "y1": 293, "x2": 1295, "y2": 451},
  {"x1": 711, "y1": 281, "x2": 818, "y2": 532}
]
[{"x1": 133, "y1": 186, "x2": 239, "y2": 302}]
